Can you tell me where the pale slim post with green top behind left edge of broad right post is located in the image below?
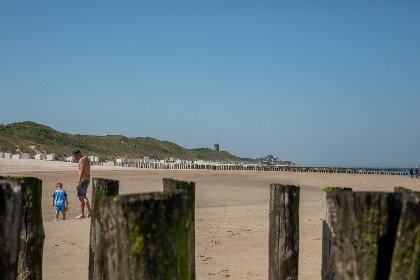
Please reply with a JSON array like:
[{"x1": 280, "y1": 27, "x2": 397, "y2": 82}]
[{"x1": 321, "y1": 187, "x2": 352, "y2": 280}]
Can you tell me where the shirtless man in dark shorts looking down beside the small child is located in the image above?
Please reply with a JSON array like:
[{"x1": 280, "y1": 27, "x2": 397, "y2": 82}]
[{"x1": 73, "y1": 150, "x2": 92, "y2": 219}]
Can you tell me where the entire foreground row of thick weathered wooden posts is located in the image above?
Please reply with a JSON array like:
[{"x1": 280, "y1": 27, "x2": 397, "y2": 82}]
[{"x1": 0, "y1": 177, "x2": 420, "y2": 280}]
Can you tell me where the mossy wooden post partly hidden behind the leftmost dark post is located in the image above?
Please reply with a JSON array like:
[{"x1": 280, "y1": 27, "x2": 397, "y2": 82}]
[{"x1": 8, "y1": 177, "x2": 45, "y2": 280}]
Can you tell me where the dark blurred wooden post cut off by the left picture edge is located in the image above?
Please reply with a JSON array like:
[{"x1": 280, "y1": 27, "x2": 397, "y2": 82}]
[{"x1": 0, "y1": 180, "x2": 23, "y2": 280}]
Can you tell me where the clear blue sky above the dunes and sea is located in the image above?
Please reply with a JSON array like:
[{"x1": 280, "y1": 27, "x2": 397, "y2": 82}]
[{"x1": 0, "y1": 0, "x2": 420, "y2": 167}]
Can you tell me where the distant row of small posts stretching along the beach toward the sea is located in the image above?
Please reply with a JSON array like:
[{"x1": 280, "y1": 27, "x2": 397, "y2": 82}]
[{"x1": 114, "y1": 161, "x2": 407, "y2": 175}]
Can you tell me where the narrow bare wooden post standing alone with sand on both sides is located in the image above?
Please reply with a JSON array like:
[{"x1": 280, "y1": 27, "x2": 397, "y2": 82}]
[{"x1": 268, "y1": 184, "x2": 300, "y2": 280}]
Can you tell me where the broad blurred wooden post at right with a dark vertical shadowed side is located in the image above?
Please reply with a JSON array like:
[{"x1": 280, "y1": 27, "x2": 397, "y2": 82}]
[{"x1": 327, "y1": 192, "x2": 402, "y2": 280}]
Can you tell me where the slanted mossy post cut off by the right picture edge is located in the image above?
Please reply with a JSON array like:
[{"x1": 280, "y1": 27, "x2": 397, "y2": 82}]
[{"x1": 389, "y1": 193, "x2": 420, "y2": 280}]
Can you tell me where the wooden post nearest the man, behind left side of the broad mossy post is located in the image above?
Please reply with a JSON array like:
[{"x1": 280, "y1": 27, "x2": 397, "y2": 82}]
[{"x1": 89, "y1": 178, "x2": 119, "y2": 279}]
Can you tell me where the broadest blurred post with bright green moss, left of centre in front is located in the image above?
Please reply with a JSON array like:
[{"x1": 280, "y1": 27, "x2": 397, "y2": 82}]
[{"x1": 99, "y1": 190, "x2": 192, "y2": 280}]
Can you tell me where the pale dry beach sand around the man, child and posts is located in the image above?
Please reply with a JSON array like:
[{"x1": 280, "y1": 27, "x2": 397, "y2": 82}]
[{"x1": 0, "y1": 159, "x2": 420, "y2": 280}]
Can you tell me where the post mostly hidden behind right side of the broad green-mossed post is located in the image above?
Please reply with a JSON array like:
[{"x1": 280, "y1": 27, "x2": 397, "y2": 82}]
[{"x1": 163, "y1": 178, "x2": 195, "y2": 280}]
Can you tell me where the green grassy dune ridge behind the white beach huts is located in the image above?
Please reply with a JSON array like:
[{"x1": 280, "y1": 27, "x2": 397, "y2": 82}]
[{"x1": 0, "y1": 121, "x2": 255, "y2": 162}]
